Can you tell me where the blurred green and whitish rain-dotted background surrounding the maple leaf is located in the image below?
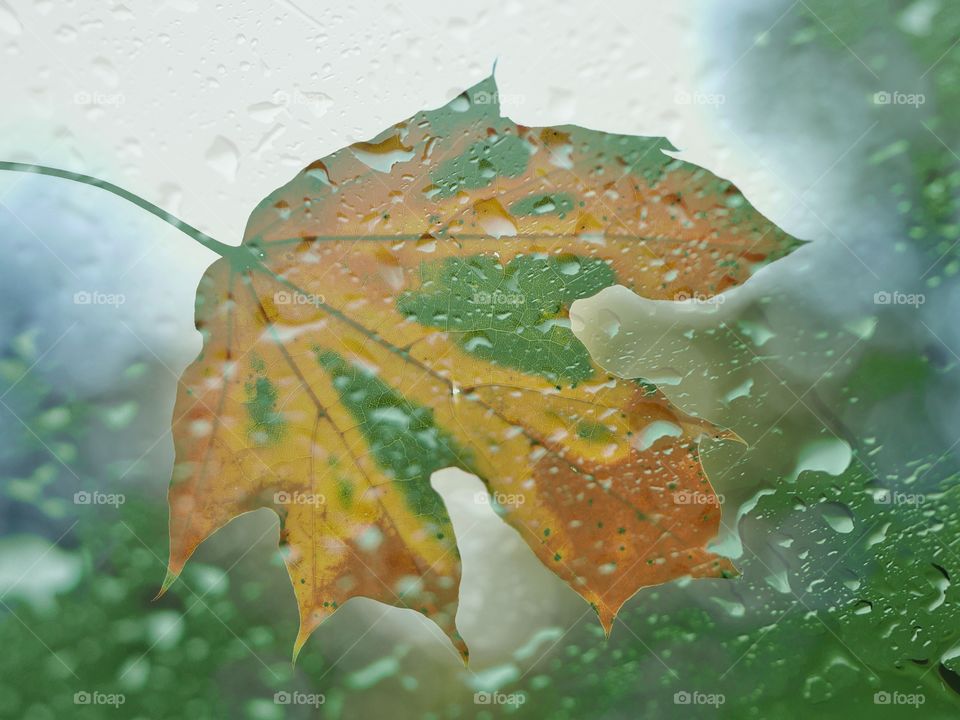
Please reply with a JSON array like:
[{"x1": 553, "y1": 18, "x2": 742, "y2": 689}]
[{"x1": 0, "y1": 0, "x2": 960, "y2": 720}]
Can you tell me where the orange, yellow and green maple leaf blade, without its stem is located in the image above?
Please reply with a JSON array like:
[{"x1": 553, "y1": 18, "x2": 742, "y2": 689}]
[{"x1": 164, "y1": 78, "x2": 797, "y2": 656}]
